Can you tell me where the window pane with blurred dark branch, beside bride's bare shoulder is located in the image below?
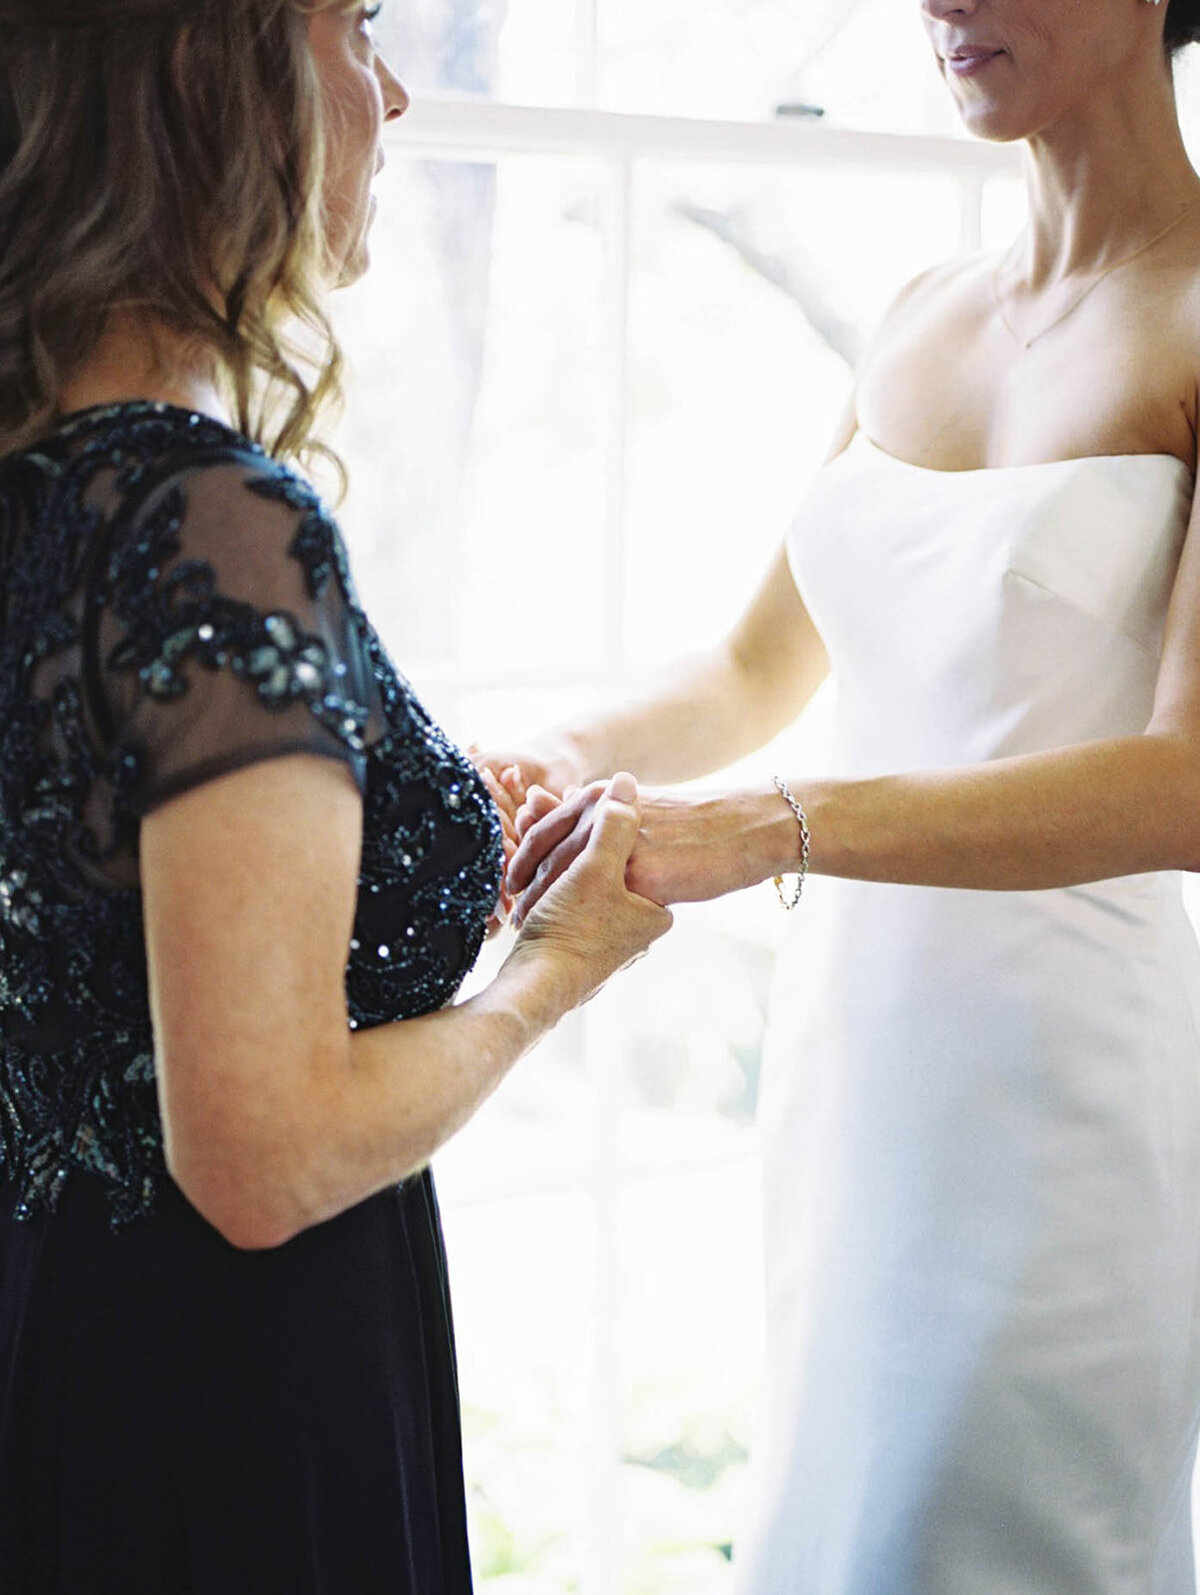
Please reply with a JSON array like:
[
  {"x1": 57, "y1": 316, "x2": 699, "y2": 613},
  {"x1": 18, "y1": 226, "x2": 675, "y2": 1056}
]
[{"x1": 629, "y1": 164, "x2": 959, "y2": 673}]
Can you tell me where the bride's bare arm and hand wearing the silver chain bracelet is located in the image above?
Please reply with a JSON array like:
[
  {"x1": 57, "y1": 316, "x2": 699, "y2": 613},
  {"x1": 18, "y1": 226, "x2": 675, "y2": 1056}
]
[{"x1": 509, "y1": 484, "x2": 1200, "y2": 911}]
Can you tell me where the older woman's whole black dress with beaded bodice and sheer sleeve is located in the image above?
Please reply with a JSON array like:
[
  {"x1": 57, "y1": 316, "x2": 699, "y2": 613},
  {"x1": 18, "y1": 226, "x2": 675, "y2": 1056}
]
[{"x1": 0, "y1": 402, "x2": 501, "y2": 1595}]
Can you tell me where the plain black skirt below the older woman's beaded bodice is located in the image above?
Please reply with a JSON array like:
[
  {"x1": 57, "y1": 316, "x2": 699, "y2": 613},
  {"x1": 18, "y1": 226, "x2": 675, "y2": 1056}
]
[{"x1": 0, "y1": 1174, "x2": 471, "y2": 1595}]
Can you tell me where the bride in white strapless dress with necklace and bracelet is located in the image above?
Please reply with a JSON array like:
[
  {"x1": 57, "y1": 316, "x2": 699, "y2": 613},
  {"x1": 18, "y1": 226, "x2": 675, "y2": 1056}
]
[{"x1": 480, "y1": 0, "x2": 1200, "y2": 1595}]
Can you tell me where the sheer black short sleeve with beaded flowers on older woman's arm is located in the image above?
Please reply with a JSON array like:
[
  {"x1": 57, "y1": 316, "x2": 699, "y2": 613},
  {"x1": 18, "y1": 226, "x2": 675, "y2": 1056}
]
[{"x1": 89, "y1": 453, "x2": 381, "y2": 817}]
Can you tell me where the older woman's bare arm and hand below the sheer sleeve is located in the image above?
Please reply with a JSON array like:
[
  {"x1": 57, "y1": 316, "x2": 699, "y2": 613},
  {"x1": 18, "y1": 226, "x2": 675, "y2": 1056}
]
[{"x1": 140, "y1": 754, "x2": 669, "y2": 1249}]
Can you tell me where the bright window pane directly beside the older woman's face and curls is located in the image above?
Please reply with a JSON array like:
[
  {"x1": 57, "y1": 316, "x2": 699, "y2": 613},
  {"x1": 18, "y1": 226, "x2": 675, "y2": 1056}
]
[{"x1": 328, "y1": 150, "x2": 606, "y2": 686}]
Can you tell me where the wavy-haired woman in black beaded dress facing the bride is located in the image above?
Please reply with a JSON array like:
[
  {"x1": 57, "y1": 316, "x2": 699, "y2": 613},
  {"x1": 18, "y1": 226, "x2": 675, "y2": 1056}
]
[{"x1": 0, "y1": 0, "x2": 669, "y2": 1595}]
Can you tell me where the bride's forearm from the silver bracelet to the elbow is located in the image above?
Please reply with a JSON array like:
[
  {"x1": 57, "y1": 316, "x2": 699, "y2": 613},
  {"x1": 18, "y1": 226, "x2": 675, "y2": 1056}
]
[{"x1": 745, "y1": 734, "x2": 1200, "y2": 892}]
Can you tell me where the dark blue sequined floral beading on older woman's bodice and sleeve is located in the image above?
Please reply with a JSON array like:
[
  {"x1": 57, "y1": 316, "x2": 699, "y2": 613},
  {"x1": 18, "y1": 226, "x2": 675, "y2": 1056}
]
[{"x1": 0, "y1": 404, "x2": 503, "y2": 1228}]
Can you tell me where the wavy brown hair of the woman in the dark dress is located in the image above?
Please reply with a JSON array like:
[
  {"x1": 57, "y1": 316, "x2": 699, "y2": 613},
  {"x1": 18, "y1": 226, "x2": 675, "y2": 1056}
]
[{"x1": 0, "y1": 0, "x2": 346, "y2": 475}]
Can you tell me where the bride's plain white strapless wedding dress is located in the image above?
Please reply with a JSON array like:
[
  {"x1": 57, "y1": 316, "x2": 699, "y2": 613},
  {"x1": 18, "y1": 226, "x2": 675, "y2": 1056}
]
[{"x1": 737, "y1": 434, "x2": 1200, "y2": 1595}]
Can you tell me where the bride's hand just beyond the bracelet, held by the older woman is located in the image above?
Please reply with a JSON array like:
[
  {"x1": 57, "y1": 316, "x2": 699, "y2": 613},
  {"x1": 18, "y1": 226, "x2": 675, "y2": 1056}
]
[{"x1": 507, "y1": 782, "x2": 764, "y2": 925}]
